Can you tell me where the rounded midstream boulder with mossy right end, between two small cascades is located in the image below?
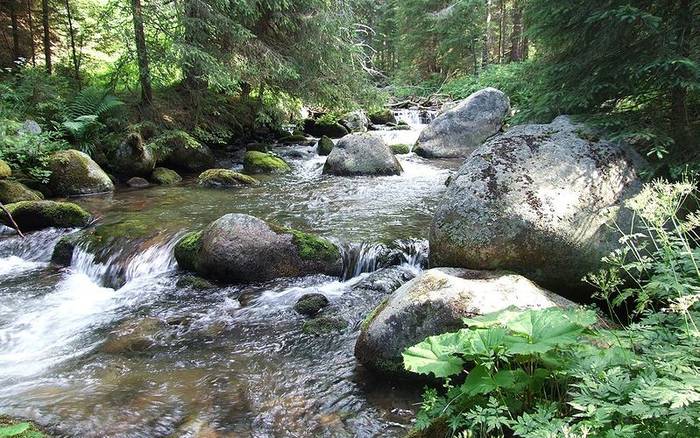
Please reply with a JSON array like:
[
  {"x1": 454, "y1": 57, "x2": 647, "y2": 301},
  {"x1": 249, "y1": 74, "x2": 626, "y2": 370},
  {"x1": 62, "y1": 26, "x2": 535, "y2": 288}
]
[{"x1": 175, "y1": 214, "x2": 343, "y2": 283}]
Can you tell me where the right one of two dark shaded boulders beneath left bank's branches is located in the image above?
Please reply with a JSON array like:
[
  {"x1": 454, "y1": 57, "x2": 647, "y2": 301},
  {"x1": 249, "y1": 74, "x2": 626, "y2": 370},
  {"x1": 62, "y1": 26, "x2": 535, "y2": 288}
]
[{"x1": 152, "y1": 130, "x2": 216, "y2": 172}]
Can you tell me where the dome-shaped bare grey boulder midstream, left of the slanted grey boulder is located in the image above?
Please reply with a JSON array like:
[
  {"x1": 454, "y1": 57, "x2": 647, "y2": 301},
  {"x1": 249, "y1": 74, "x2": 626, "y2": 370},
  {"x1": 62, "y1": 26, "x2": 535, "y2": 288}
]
[{"x1": 323, "y1": 134, "x2": 403, "y2": 176}]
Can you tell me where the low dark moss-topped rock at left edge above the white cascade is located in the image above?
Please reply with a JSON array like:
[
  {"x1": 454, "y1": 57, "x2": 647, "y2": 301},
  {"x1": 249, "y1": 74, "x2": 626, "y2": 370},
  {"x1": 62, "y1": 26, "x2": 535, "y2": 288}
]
[{"x1": 0, "y1": 201, "x2": 91, "y2": 231}]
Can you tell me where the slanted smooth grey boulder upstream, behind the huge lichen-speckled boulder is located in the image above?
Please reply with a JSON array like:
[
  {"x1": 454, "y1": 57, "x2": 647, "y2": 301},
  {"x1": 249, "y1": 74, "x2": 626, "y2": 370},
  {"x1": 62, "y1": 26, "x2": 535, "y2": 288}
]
[{"x1": 414, "y1": 88, "x2": 510, "y2": 158}]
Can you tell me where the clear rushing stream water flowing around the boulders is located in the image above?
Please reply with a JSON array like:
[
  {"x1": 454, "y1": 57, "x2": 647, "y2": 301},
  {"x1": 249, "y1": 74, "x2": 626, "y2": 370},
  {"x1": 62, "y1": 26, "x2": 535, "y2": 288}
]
[{"x1": 0, "y1": 114, "x2": 459, "y2": 437}]
